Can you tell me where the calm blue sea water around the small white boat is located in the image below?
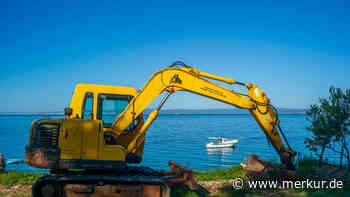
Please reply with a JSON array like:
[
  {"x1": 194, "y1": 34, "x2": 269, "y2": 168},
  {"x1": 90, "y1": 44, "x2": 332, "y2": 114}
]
[{"x1": 0, "y1": 114, "x2": 318, "y2": 170}]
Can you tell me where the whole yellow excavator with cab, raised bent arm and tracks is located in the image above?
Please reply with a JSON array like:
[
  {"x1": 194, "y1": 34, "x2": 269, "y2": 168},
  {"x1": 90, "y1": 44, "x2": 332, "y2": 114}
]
[{"x1": 25, "y1": 62, "x2": 295, "y2": 197}]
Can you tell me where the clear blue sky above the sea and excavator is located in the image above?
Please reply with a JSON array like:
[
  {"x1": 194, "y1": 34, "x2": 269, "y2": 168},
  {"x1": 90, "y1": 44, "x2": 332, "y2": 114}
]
[{"x1": 0, "y1": 0, "x2": 350, "y2": 112}]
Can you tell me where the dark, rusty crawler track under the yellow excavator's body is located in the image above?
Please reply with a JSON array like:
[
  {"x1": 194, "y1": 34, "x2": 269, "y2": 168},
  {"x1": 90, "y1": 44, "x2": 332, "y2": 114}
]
[{"x1": 32, "y1": 167, "x2": 175, "y2": 197}]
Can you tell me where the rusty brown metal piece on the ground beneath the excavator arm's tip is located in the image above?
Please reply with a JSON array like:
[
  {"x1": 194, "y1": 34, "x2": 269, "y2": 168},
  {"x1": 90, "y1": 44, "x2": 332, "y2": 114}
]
[{"x1": 240, "y1": 153, "x2": 296, "y2": 180}]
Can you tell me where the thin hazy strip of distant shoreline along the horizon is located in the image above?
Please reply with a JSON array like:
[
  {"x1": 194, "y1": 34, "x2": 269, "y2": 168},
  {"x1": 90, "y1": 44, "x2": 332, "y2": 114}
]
[{"x1": 0, "y1": 108, "x2": 306, "y2": 116}]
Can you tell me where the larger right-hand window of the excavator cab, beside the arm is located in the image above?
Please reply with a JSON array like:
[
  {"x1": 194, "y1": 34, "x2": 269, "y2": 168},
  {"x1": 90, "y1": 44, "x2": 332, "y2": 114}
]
[{"x1": 98, "y1": 94, "x2": 132, "y2": 128}]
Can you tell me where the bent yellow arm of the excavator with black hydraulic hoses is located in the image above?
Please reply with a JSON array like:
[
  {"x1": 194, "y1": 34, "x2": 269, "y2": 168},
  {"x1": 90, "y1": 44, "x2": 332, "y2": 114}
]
[{"x1": 112, "y1": 62, "x2": 295, "y2": 170}]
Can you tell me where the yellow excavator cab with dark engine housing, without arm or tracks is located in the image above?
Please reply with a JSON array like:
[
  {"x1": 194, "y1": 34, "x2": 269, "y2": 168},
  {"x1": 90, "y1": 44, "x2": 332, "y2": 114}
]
[{"x1": 26, "y1": 84, "x2": 144, "y2": 169}]
